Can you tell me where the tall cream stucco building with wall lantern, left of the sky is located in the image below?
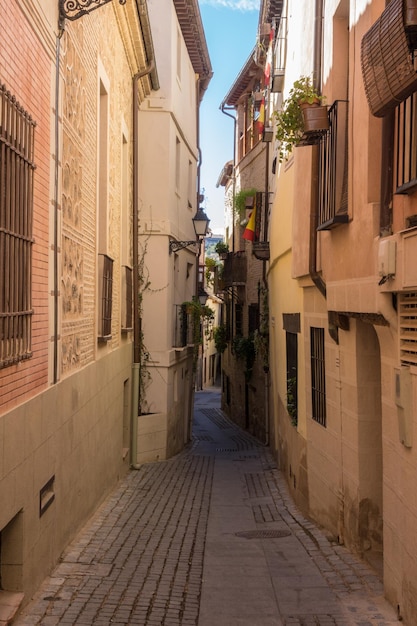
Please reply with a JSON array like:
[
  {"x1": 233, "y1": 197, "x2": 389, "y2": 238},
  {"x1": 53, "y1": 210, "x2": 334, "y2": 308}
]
[{"x1": 137, "y1": 0, "x2": 212, "y2": 462}]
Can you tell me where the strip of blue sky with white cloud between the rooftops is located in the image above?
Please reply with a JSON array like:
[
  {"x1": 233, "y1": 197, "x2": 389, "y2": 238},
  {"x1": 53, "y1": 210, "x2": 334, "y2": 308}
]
[{"x1": 199, "y1": 0, "x2": 259, "y2": 232}]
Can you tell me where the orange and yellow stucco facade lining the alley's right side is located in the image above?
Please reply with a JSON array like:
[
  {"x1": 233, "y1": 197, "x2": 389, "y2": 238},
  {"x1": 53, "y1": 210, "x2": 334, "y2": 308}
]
[{"x1": 221, "y1": 0, "x2": 417, "y2": 624}]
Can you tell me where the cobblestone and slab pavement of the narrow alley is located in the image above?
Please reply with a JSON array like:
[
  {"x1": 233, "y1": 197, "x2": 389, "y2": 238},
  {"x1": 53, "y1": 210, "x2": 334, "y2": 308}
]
[{"x1": 14, "y1": 390, "x2": 398, "y2": 626}]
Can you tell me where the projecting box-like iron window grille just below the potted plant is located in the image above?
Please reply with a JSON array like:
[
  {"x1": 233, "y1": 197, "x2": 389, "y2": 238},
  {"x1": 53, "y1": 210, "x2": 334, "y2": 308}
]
[{"x1": 318, "y1": 100, "x2": 349, "y2": 230}]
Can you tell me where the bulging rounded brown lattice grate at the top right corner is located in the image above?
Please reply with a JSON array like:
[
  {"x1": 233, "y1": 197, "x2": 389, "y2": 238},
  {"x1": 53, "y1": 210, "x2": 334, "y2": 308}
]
[{"x1": 361, "y1": 0, "x2": 417, "y2": 117}]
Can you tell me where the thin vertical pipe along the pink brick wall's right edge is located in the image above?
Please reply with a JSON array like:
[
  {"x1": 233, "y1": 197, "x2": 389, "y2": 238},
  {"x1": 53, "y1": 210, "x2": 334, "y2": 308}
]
[{"x1": 53, "y1": 28, "x2": 64, "y2": 385}]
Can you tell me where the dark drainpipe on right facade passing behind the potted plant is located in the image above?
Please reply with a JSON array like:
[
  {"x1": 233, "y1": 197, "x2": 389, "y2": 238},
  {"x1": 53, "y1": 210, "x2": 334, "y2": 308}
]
[{"x1": 309, "y1": 0, "x2": 326, "y2": 297}]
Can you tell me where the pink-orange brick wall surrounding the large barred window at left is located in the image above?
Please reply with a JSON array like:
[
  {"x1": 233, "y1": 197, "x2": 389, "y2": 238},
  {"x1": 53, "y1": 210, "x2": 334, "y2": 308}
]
[{"x1": 0, "y1": 0, "x2": 53, "y2": 411}]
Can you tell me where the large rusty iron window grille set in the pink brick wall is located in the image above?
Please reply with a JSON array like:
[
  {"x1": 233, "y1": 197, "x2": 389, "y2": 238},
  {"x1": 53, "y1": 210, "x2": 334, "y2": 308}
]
[{"x1": 0, "y1": 85, "x2": 35, "y2": 367}]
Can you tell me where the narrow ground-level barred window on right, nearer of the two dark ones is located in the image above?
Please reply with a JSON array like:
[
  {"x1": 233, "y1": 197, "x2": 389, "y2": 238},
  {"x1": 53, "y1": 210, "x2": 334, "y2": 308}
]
[{"x1": 310, "y1": 327, "x2": 326, "y2": 426}]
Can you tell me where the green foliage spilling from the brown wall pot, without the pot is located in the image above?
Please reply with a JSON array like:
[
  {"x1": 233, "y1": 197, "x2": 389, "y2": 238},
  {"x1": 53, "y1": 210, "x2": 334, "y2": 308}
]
[{"x1": 273, "y1": 76, "x2": 324, "y2": 163}]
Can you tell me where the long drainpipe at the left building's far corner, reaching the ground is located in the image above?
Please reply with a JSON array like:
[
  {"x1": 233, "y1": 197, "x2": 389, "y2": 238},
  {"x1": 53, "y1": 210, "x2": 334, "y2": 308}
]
[{"x1": 130, "y1": 60, "x2": 155, "y2": 469}]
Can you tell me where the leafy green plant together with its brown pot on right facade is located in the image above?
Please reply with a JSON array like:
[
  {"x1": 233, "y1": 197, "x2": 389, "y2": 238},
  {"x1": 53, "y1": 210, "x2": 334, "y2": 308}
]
[{"x1": 274, "y1": 76, "x2": 329, "y2": 162}]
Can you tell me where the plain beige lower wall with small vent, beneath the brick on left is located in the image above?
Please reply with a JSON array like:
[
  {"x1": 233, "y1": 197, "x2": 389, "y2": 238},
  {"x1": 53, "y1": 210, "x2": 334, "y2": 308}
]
[{"x1": 0, "y1": 346, "x2": 131, "y2": 601}]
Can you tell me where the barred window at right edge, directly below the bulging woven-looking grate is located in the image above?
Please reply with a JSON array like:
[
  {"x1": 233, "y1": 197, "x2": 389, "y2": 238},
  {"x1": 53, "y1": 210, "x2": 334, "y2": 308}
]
[{"x1": 395, "y1": 93, "x2": 417, "y2": 194}]
